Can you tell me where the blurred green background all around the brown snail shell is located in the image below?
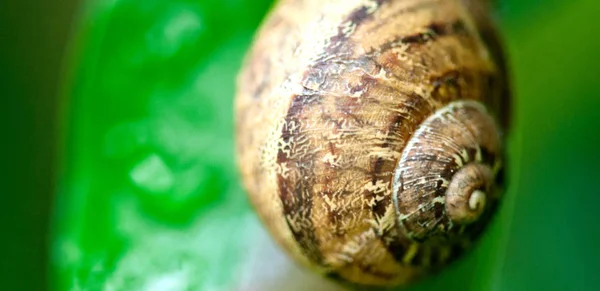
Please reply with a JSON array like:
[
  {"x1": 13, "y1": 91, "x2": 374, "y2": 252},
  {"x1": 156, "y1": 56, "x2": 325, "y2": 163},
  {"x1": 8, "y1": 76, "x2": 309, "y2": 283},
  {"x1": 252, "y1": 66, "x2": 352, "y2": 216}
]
[{"x1": 0, "y1": 0, "x2": 600, "y2": 290}]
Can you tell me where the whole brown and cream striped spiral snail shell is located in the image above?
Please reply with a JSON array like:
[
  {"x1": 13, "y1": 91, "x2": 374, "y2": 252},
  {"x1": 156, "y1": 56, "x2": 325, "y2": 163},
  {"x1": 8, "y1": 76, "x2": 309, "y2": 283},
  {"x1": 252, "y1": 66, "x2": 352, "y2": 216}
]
[{"x1": 235, "y1": 0, "x2": 510, "y2": 286}]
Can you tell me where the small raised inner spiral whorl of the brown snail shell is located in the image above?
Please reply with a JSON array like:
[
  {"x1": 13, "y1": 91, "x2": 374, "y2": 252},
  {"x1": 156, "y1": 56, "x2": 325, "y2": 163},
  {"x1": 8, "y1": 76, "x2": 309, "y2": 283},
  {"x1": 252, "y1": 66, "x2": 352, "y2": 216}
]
[{"x1": 392, "y1": 101, "x2": 500, "y2": 241}]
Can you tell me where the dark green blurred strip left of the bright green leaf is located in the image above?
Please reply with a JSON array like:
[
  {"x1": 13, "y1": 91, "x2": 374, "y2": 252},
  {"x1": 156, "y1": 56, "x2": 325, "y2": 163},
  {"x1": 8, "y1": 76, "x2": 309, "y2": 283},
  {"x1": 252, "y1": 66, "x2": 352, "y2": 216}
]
[{"x1": 0, "y1": 0, "x2": 76, "y2": 290}]
